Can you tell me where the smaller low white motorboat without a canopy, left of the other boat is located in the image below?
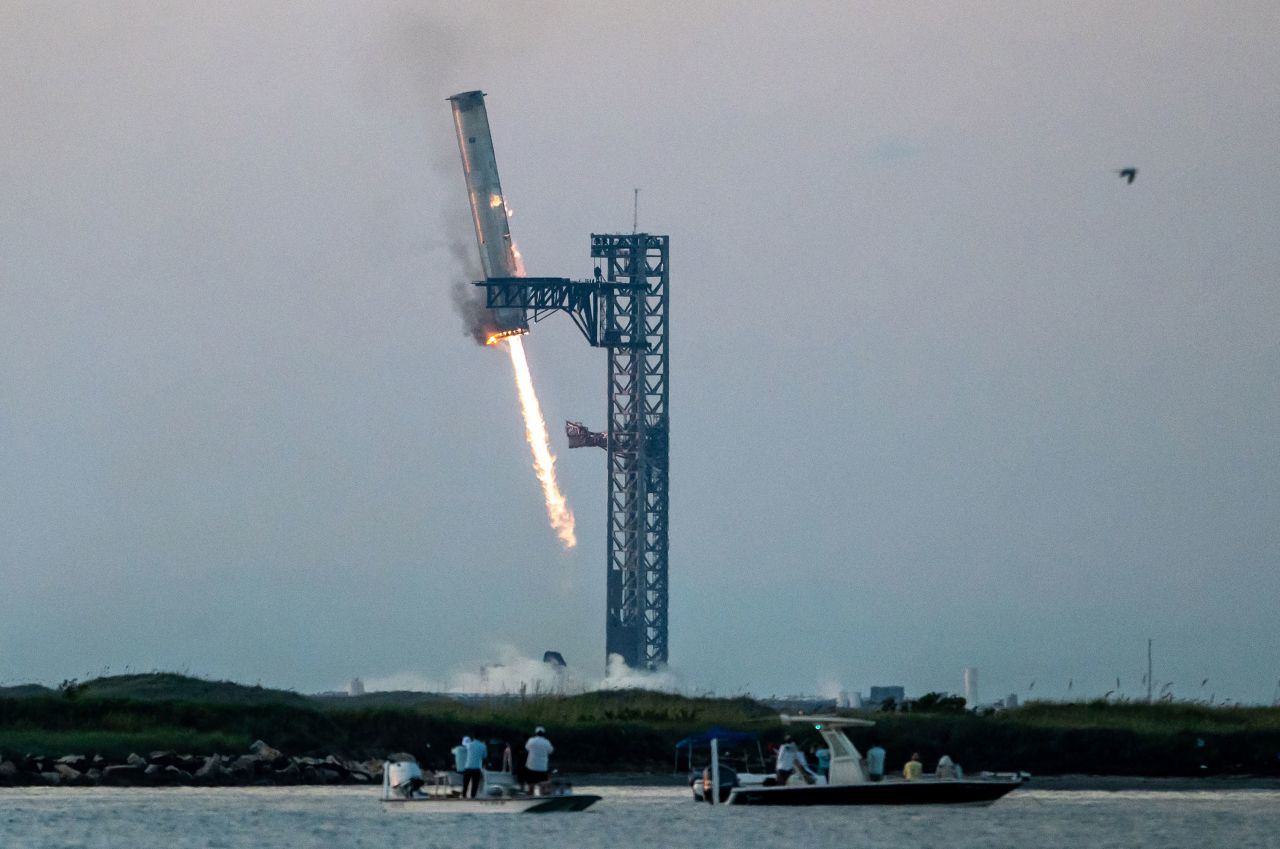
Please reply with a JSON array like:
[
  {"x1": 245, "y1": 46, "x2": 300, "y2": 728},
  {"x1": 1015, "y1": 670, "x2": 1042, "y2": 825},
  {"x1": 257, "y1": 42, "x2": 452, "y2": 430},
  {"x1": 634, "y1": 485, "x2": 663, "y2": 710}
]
[{"x1": 381, "y1": 761, "x2": 600, "y2": 813}]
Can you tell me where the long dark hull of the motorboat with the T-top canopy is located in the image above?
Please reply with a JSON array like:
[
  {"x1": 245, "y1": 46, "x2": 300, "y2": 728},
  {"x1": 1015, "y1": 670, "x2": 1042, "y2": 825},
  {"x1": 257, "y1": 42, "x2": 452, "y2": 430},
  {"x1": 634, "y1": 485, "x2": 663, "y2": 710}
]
[{"x1": 728, "y1": 780, "x2": 1023, "y2": 805}]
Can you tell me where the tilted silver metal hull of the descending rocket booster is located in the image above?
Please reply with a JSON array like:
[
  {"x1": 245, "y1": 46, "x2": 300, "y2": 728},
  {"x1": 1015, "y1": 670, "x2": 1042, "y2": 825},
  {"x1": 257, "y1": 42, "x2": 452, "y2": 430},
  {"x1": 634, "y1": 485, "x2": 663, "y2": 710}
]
[{"x1": 449, "y1": 91, "x2": 529, "y2": 332}]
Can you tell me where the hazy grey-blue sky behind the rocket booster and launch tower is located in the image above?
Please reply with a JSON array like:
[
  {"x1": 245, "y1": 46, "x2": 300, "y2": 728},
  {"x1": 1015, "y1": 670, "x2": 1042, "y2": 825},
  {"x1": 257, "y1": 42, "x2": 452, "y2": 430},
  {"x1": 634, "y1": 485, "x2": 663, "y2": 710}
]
[{"x1": 0, "y1": 1, "x2": 1280, "y2": 702}]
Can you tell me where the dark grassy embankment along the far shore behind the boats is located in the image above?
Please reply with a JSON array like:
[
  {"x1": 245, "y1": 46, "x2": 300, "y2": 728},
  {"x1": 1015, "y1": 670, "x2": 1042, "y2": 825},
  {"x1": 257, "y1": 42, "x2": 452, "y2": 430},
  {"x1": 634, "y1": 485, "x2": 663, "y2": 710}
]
[{"x1": 0, "y1": 675, "x2": 1280, "y2": 776}]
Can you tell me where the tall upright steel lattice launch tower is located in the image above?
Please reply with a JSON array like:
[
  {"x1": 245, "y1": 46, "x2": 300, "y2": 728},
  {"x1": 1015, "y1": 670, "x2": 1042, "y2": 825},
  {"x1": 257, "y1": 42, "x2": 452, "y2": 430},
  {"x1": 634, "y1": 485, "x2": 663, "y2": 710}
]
[{"x1": 591, "y1": 233, "x2": 669, "y2": 670}]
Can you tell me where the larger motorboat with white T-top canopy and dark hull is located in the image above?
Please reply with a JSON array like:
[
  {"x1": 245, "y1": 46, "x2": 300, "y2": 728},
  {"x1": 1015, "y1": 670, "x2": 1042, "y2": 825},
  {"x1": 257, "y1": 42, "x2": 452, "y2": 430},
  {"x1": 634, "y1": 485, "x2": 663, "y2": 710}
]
[{"x1": 701, "y1": 715, "x2": 1027, "y2": 805}]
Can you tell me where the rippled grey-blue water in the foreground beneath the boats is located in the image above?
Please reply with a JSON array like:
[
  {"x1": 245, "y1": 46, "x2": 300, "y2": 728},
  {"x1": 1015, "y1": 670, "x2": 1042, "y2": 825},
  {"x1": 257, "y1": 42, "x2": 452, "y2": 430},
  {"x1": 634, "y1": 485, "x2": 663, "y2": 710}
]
[{"x1": 0, "y1": 788, "x2": 1280, "y2": 849}]
